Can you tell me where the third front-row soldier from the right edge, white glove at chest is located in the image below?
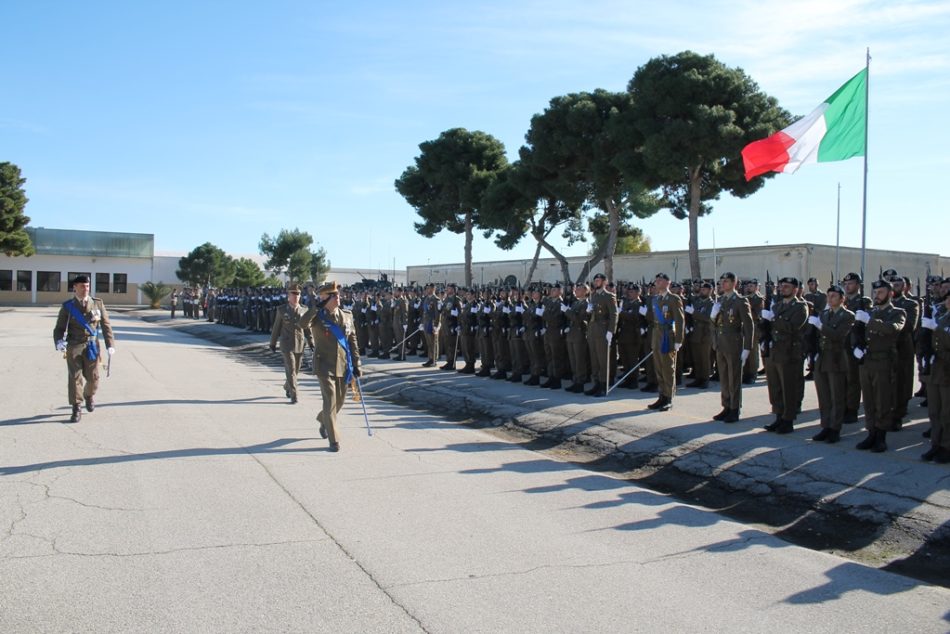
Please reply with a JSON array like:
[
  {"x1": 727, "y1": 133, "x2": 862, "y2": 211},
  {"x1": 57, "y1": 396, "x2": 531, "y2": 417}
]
[{"x1": 808, "y1": 285, "x2": 854, "y2": 443}]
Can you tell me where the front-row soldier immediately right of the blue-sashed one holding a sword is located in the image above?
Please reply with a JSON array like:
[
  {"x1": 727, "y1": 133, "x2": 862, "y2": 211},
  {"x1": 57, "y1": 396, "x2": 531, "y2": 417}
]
[{"x1": 710, "y1": 272, "x2": 755, "y2": 423}]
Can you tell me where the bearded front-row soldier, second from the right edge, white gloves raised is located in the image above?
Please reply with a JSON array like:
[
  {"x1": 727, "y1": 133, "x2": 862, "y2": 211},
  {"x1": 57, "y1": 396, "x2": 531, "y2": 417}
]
[{"x1": 853, "y1": 280, "x2": 907, "y2": 453}]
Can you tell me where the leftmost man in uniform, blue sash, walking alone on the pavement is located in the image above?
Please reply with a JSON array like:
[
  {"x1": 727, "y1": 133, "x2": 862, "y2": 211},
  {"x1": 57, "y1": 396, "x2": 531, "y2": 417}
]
[{"x1": 53, "y1": 275, "x2": 115, "y2": 423}]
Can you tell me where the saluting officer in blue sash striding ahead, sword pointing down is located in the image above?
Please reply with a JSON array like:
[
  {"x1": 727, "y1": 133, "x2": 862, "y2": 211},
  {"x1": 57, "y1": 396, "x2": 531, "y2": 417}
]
[{"x1": 304, "y1": 282, "x2": 360, "y2": 452}]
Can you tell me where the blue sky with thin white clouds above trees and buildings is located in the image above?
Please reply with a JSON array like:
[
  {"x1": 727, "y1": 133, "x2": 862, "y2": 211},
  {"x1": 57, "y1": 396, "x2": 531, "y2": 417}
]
[{"x1": 0, "y1": 0, "x2": 950, "y2": 274}]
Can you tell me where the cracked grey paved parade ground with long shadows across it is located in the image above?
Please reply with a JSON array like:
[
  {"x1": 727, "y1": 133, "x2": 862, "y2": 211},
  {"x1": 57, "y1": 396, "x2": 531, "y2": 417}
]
[{"x1": 0, "y1": 308, "x2": 950, "y2": 632}]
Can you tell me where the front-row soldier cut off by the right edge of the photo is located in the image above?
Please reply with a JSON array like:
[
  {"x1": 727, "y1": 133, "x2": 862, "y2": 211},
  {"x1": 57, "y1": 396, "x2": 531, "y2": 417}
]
[{"x1": 920, "y1": 294, "x2": 950, "y2": 464}]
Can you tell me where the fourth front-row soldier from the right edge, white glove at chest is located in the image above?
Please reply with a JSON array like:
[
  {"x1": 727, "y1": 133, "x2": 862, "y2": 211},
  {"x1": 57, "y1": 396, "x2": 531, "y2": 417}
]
[{"x1": 761, "y1": 277, "x2": 808, "y2": 434}]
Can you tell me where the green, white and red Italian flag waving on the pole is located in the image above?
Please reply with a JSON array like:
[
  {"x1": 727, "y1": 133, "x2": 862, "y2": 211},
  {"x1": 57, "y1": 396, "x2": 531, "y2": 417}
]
[{"x1": 742, "y1": 68, "x2": 868, "y2": 181}]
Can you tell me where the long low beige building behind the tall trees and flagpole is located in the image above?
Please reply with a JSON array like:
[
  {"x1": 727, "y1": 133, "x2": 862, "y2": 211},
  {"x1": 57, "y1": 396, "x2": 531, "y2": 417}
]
[{"x1": 406, "y1": 244, "x2": 950, "y2": 289}]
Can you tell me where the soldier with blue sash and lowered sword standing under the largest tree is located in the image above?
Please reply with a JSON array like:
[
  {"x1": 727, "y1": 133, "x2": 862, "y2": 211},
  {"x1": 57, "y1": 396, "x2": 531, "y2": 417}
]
[{"x1": 647, "y1": 273, "x2": 686, "y2": 412}]
